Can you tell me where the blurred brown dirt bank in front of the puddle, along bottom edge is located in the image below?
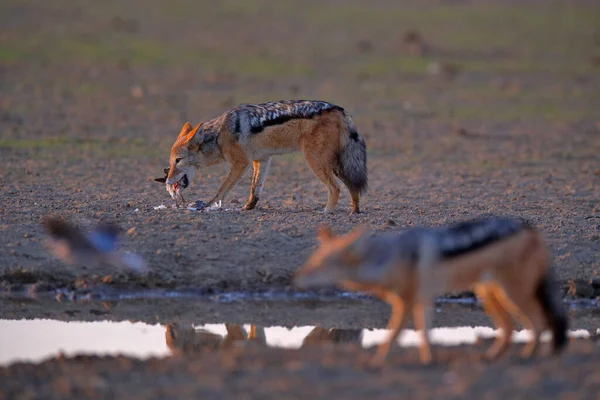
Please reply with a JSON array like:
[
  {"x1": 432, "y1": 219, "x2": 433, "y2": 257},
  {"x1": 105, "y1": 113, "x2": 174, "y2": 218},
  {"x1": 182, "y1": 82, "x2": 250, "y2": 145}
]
[{"x1": 0, "y1": 340, "x2": 600, "y2": 399}]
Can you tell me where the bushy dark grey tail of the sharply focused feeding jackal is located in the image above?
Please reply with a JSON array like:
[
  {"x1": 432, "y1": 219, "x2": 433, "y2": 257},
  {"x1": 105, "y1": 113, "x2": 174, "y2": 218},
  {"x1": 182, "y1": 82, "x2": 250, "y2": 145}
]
[{"x1": 336, "y1": 115, "x2": 367, "y2": 193}]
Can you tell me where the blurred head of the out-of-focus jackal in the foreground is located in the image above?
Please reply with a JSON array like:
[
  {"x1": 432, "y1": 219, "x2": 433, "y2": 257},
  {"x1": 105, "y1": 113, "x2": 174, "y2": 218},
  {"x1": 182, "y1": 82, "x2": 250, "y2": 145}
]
[{"x1": 294, "y1": 226, "x2": 372, "y2": 288}]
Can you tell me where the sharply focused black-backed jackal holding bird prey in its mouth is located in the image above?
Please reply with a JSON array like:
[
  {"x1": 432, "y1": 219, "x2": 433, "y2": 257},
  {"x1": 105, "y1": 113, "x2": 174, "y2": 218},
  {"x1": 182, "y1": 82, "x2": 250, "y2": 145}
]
[{"x1": 156, "y1": 100, "x2": 367, "y2": 213}]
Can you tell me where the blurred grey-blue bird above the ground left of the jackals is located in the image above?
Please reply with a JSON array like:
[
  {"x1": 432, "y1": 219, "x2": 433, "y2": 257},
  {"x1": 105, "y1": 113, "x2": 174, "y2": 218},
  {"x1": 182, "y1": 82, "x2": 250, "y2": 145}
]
[{"x1": 42, "y1": 218, "x2": 148, "y2": 274}]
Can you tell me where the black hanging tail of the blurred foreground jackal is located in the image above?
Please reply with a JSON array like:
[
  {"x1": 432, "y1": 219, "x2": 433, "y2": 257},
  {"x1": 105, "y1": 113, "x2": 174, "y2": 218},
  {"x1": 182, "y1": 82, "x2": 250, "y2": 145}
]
[{"x1": 535, "y1": 272, "x2": 569, "y2": 354}]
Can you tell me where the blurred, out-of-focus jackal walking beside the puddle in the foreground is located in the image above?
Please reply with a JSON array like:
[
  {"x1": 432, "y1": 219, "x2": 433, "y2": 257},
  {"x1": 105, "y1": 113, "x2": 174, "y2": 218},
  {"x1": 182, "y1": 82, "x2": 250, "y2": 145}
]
[{"x1": 294, "y1": 218, "x2": 568, "y2": 365}]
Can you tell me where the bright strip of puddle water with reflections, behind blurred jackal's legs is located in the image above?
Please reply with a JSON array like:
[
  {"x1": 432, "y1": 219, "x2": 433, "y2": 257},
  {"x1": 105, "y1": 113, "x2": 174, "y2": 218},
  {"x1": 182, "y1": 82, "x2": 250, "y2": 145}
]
[{"x1": 0, "y1": 319, "x2": 600, "y2": 365}]
